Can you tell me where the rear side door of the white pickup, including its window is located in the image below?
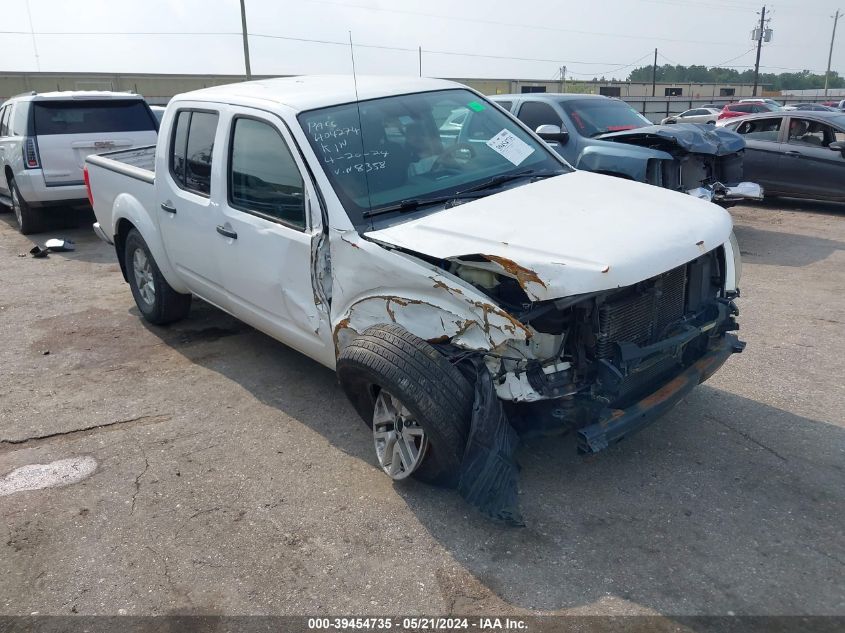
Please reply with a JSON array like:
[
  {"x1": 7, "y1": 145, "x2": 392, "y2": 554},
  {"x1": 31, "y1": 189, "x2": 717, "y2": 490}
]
[{"x1": 157, "y1": 103, "x2": 228, "y2": 309}]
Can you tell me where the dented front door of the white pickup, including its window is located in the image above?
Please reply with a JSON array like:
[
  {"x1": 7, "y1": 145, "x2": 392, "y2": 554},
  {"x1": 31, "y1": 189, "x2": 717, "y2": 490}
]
[{"x1": 215, "y1": 107, "x2": 334, "y2": 365}]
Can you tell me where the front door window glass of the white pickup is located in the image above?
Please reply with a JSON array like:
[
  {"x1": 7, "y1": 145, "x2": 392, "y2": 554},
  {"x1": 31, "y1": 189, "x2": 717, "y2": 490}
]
[{"x1": 227, "y1": 117, "x2": 305, "y2": 229}]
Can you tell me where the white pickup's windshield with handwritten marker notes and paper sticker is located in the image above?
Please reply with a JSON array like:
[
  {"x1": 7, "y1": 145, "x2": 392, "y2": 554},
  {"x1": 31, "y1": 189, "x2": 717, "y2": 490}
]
[{"x1": 299, "y1": 89, "x2": 569, "y2": 226}]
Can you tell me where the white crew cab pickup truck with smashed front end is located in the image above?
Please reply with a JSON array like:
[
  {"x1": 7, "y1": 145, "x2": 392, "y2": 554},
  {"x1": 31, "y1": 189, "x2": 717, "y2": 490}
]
[{"x1": 86, "y1": 77, "x2": 743, "y2": 494}]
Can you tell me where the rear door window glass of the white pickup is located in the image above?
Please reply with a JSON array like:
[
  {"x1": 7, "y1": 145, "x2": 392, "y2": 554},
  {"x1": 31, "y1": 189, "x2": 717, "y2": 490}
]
[{"x1": 170, "y1": 110, "x2": 218, "y2": 196}]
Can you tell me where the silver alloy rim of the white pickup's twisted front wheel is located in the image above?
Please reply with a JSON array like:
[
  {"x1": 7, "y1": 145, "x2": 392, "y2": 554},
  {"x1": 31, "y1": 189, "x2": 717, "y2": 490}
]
[{"x1": 373, "y1": 389, "x2": 428, "y2": 480}]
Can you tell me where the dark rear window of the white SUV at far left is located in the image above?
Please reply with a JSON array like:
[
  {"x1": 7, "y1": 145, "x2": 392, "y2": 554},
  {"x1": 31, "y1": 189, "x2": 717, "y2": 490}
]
[{"x1": 33, "y1": 99, "x2": 156, "y2": 136}]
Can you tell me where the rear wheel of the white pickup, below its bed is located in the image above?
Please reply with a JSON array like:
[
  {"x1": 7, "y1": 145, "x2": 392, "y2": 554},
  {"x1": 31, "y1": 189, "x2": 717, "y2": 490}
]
[{"x1": 123, "y1": 229, "x2": 191, "y2": 325}]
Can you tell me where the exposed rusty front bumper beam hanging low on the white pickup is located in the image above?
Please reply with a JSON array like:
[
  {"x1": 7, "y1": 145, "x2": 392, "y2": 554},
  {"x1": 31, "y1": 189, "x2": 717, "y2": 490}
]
[{"x1": 578, "y1": 334, "x2": 745, "y2": 453}]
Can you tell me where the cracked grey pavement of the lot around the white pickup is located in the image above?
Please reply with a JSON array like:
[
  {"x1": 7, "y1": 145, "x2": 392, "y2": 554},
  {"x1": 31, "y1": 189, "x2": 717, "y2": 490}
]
[{"x1": 0, "y1": 202, "x2": 845, "y2": 615}]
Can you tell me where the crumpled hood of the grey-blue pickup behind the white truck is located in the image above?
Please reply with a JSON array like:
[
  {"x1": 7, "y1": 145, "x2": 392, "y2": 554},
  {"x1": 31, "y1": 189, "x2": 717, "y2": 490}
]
[{"x1": 599, "y1": 123, "x2": 745, "y2": 156}]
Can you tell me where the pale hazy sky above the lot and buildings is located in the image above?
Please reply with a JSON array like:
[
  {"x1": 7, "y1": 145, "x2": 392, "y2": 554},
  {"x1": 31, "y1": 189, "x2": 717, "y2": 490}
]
[{"x1": 0, "y1": 0, "x2": 845, "y2": 79}]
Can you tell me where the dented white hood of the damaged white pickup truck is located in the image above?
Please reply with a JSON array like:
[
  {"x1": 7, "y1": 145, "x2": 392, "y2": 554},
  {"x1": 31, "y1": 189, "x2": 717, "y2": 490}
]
[{"x1": 365, "y1": 171, "x2": 732, "y2": 301}]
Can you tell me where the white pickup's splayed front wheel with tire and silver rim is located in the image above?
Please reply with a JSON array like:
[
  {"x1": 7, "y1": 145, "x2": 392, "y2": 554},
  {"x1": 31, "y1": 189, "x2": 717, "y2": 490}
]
[{"x1": 337, "y1": 324, "x2": 475, "y2": 486}]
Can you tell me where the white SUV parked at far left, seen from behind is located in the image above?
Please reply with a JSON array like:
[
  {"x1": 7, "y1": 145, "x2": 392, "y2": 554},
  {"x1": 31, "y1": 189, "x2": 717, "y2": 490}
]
[{"x1": 0, "y1": 91, "x2": 158, "y2": 235}]
